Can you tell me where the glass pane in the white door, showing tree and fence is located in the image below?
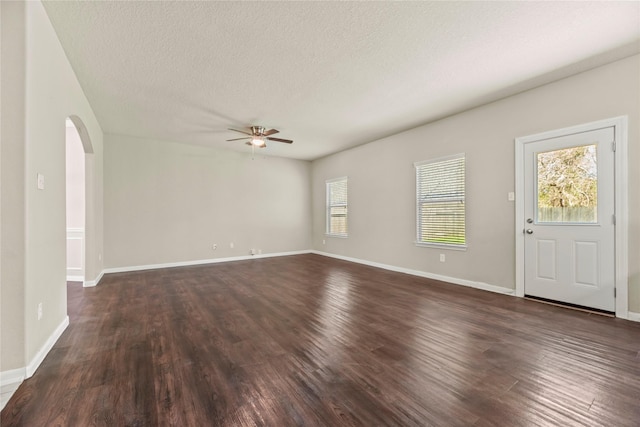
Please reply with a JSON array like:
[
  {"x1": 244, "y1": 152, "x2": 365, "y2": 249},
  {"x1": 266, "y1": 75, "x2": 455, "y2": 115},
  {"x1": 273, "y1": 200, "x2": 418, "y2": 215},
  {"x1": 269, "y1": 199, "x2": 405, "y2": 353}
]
[{"x1": 537, "y1": 144, "x2": 598, "y2": 224}]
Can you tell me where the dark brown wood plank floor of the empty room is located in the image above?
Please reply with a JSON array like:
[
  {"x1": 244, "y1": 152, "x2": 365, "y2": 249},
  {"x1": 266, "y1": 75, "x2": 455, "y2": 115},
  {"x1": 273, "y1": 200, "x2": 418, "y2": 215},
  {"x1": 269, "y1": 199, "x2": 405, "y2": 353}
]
[{"x1": 1, "y1": 255, "x2": 640, "y2": 427}]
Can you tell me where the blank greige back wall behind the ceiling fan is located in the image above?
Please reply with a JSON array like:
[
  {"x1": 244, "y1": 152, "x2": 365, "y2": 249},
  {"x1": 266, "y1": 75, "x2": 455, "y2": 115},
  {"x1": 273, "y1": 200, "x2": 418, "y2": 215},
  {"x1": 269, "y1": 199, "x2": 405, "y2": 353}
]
[{"x1": 104, "y1": 134, "x2": 311, "y2": 268}]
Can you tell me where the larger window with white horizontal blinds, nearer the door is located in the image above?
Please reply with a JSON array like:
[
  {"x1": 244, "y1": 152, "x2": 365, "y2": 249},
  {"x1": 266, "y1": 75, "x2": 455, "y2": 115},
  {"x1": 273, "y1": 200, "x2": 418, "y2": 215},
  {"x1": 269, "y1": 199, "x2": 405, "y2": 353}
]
[{"x1": 415, "y1": 153, "x2": 466, "y2": 248}]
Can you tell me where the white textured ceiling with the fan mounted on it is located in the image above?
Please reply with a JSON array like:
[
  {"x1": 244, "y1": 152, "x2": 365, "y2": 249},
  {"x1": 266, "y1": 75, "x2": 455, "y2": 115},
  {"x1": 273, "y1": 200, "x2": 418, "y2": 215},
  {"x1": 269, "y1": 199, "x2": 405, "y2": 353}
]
[{"x1": 45, "y1": 1, "x2": 640, "y2": 160}]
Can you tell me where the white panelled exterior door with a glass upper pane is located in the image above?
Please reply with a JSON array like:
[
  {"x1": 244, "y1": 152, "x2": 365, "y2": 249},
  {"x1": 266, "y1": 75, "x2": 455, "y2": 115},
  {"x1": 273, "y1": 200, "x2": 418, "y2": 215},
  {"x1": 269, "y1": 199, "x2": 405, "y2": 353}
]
[{"x1": 522, "y1": 126, "x2": 615, "y2": 312}]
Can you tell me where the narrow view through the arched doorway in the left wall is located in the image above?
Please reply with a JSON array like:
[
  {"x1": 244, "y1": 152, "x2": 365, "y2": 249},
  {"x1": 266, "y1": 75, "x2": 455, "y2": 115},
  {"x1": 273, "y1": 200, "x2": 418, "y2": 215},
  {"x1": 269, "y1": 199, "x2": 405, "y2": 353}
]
[{"x1": 65, "y1": 118, "x2": 86, "y2": 282}]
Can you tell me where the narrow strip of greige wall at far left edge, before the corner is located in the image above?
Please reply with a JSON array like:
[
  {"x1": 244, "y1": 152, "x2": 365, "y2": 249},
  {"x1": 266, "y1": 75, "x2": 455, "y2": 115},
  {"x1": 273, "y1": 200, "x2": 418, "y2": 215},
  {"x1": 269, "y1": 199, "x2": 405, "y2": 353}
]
[{"x1": 0, "y1": 2, "x2": 26, "y2": 371}]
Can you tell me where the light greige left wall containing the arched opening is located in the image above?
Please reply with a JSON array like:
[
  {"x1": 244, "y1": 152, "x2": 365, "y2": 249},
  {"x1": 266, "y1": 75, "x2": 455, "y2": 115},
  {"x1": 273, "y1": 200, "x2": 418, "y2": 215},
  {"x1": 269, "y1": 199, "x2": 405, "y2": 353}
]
[{"x1": 0, "y1": 2, "x2": 102, "y2": 372}]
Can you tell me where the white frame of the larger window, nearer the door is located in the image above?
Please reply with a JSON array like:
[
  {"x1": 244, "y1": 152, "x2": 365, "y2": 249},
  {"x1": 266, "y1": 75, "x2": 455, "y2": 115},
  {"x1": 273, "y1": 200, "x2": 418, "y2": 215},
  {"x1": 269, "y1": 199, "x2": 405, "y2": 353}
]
[{"x1": 414, "y1": 153, "x2": 468, "y2": 251}]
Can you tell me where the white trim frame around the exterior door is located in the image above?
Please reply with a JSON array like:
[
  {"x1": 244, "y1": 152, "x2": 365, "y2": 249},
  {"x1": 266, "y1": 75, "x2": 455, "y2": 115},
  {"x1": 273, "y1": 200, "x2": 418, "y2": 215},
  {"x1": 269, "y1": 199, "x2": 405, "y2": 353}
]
[{"x1": 515, "y1": 116, "x2": 629, "y2": 319}]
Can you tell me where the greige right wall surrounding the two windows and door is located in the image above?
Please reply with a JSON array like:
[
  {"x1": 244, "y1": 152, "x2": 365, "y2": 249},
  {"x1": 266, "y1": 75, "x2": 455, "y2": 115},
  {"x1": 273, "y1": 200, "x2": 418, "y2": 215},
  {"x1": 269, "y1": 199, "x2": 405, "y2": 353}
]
[{"x1": 312, "y1": 55, "x2": 640, "y2": 313}]
